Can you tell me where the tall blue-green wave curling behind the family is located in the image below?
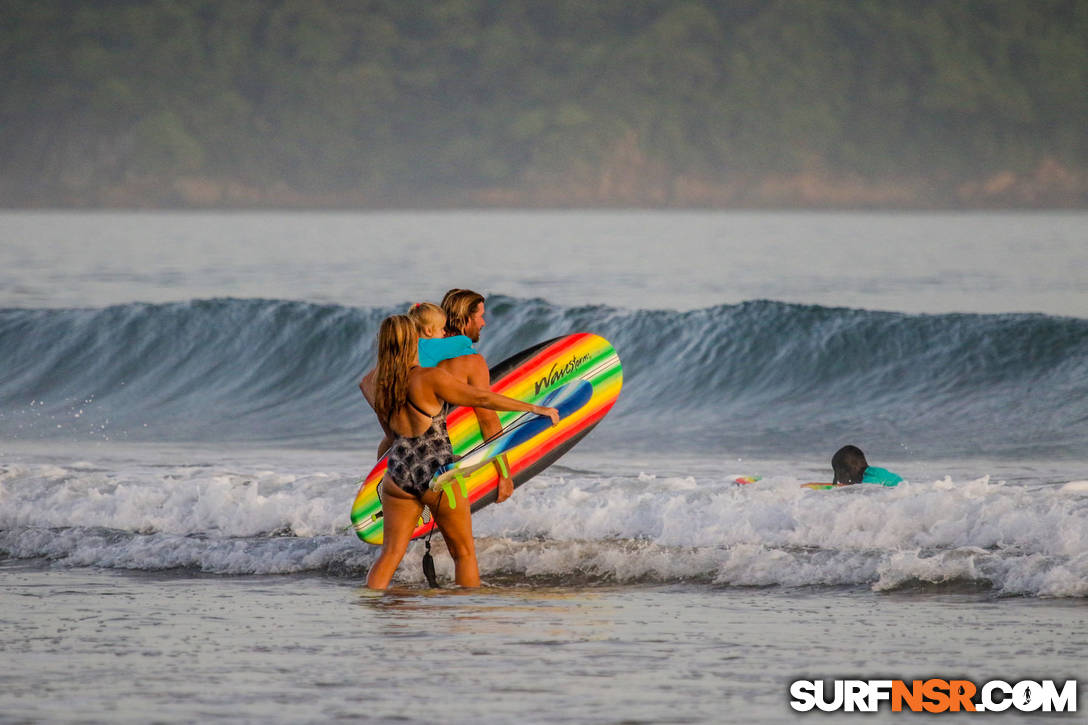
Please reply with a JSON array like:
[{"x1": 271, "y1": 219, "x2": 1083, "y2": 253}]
[{"x1": 0, "y1": 296, "x2": 1088, "y2": 456}]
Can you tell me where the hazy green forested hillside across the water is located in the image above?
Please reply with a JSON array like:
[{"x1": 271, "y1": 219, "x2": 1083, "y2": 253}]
[{"x1": 0, "y1": 0, "x2": 1088, "y2": 207}]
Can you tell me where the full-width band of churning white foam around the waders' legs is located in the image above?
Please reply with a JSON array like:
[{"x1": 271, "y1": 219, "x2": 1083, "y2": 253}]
[{"x1": 0, "y1": 462, "x2": 1088, "y2": 597}]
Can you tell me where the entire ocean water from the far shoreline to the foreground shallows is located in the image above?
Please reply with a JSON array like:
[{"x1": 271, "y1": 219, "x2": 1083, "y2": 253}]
[{"x1": 0, "y1": 212, "x2": 1088, "y2": 723}]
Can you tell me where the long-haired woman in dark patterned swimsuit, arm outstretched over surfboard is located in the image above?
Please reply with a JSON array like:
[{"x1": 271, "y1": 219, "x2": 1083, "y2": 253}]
[{"x1": 363, "y1": 315, "x2": 559, "y2": 589}]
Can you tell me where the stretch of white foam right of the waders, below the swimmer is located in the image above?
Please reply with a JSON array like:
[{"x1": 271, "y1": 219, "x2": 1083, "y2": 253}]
[{"x1": 477, "y1": 474, "x2": 1088, "y2": 597}]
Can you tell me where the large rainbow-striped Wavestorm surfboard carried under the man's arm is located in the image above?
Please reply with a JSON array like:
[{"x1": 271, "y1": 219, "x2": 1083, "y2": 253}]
[{"x1": 351, "y1": 332, "x2": 623, "y2": 545}]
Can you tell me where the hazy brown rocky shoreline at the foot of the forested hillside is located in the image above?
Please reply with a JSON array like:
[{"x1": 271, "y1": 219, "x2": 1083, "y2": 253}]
[{"x1": 6, "y1": 159, "x2": 1088, "y2": 211}]
